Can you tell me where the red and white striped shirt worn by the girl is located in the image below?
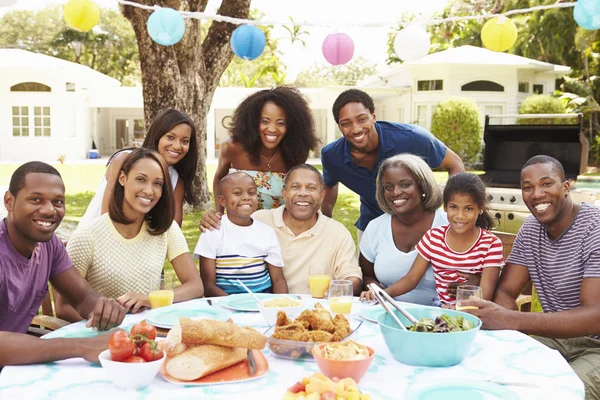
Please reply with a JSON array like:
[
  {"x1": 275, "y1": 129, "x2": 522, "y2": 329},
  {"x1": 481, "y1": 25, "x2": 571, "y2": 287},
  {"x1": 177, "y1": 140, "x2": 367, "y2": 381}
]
[{"x1": 417, "y1": 225, "x2": 504, "y2": 304}]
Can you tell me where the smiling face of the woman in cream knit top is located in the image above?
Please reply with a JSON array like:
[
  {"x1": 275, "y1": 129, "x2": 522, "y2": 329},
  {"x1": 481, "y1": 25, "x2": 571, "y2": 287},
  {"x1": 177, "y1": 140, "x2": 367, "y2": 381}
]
[{"x1": 119, "y1": 158, "x2": 165, "y2": 219}]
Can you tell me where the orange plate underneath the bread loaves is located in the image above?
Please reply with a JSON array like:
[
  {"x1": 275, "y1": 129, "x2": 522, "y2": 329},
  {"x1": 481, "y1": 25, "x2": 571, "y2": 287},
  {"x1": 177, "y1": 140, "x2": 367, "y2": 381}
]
[{"x1": 160, "y1": 350, "x2": 269, "y2": 386}]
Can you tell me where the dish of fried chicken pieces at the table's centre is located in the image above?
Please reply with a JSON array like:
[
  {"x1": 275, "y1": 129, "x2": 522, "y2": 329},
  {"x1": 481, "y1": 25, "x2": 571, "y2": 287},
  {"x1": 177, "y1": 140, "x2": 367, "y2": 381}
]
[{"x1": 265, "y1": 303, "x2": 363, "y2": 361}]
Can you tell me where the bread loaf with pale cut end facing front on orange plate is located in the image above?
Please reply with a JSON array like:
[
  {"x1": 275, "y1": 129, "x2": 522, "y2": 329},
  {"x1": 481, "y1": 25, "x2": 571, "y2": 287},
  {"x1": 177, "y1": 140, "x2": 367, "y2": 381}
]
[{"x1": 165, "y1": 345, "x2": 247, "y2": 381}]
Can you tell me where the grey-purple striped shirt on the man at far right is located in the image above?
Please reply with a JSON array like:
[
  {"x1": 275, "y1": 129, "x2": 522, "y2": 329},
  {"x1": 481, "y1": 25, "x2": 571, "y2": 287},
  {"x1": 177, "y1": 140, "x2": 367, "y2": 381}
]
[{"x1": 506, "y1": 203, "x2": 600, "y2": 339}]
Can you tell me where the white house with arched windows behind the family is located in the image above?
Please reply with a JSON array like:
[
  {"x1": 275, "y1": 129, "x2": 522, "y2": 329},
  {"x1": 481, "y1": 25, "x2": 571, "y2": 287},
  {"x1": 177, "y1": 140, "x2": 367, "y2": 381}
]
[{"x1": 0, "y1": 46, "x2": 570, "y2": 162}]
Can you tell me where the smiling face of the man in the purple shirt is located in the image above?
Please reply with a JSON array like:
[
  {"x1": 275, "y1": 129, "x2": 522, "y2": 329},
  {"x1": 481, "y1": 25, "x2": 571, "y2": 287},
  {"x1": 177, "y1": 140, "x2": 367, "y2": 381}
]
[{"x1": 4, "y1": 173, "x2": 65, "y2": 247}]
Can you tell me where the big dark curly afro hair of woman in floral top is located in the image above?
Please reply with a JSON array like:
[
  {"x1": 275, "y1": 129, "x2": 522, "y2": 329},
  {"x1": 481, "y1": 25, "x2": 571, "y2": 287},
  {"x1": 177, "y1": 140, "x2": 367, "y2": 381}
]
[{"x1": 230, "y1": 86, "x2": 318, "y2": 170}]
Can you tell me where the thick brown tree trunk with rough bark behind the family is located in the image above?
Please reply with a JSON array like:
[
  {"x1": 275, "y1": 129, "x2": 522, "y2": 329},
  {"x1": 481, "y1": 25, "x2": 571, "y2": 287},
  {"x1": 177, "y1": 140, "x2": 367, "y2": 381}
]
[{"x1": 120, "y1": 0, "x2": 250, "y2": 209}]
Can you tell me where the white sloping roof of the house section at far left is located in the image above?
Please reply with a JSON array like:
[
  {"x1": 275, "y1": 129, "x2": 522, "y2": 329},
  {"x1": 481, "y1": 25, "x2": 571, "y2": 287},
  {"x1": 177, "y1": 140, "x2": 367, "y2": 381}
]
[{"x1": 0, "y1": 49, "x2": 121, "y2": 88}]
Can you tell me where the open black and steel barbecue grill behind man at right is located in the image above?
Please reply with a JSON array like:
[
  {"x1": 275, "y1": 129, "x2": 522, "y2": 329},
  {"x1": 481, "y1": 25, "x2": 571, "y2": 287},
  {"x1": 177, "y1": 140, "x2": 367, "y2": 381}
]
[{"x1": 481, "y1": 114, "x2": 597, "y2": 233}]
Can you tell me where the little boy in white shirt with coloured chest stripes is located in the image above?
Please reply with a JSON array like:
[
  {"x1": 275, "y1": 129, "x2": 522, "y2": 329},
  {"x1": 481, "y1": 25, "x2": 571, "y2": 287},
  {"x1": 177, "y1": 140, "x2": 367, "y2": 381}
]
[{"x1": 194, "y1": 172, "x2": 288, "y2": 297}]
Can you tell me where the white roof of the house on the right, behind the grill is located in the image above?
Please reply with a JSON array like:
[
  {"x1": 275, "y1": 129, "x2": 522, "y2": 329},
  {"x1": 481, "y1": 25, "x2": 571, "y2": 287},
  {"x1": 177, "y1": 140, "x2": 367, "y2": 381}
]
[{"x1": 361, "y1": 46, "x2": 571, "y2": 86}]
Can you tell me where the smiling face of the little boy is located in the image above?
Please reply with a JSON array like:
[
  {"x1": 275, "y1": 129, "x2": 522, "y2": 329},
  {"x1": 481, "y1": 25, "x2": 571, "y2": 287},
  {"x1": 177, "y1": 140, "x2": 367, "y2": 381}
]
[{"x1": 219, "y1": 172, "x2": 258, "y2": 223}]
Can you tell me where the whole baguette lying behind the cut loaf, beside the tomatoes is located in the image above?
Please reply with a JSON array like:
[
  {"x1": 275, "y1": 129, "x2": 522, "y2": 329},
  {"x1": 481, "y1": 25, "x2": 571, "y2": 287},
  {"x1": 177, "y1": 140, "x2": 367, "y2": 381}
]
[{"x1": 179, "y1": 318, "x2": 267, "y2": 350}]
